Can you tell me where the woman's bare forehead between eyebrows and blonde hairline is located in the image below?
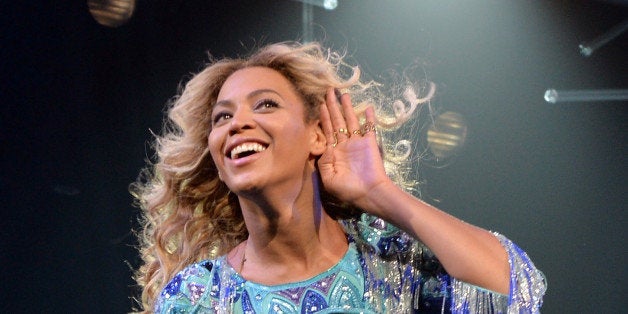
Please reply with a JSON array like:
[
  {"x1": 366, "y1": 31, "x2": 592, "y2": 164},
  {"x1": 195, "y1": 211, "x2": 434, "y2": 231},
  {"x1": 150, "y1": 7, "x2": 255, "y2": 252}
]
[{"x1": 218, "y1": 67, "x2": 297, "y2": 100}]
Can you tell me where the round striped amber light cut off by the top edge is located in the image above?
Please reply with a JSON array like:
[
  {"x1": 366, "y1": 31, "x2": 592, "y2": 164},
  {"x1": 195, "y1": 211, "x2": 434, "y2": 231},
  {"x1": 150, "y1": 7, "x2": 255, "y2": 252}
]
[{"x1": 87, "y1": 0, "x2": 135, "y2": 27}]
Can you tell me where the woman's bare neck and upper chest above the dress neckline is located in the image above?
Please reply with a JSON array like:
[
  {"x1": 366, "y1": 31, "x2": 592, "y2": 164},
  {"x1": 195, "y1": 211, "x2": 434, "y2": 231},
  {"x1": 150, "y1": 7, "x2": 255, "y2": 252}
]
[{"x1": 230, "y1": 169, "x2": 348, "y2": 284}]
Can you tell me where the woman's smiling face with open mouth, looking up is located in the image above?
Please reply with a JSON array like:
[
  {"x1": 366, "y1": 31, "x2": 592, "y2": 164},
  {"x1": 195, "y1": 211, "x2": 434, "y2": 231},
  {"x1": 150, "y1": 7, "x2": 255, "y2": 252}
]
[{"x1": 208, "y1": 67, "x2": 325, "y2": 194}]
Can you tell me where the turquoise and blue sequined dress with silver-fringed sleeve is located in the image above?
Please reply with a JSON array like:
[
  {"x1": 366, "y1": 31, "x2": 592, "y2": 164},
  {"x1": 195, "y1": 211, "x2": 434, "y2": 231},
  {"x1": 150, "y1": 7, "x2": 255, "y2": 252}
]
[{"x1": 155, "y1": 215, "x2": 546, "y2": 314}]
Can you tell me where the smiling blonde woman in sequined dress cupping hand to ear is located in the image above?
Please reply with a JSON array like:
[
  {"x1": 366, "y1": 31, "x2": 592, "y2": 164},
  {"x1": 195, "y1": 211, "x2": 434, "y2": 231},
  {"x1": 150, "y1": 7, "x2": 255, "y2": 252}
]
[{"x1": 134, "y1": 44, "x2": 545, "y2": 313}]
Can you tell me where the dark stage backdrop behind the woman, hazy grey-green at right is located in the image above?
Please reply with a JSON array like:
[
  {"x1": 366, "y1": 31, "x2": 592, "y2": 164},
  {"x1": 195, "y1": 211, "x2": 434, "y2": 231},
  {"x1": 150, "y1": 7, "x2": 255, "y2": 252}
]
[{"x1": 0, "y1": 0, "x2": 628, "y2": 313}]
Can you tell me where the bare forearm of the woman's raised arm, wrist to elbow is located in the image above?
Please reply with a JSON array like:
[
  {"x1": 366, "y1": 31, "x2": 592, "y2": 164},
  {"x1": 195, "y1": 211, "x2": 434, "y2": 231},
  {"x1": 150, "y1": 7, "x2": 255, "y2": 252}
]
[{"x1": 356, "y1": 182, "x2": 510, "y2": 294}]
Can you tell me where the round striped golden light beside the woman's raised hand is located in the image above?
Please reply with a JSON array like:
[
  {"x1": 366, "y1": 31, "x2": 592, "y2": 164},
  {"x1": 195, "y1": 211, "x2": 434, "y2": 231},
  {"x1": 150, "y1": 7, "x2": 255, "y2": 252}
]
[{"x1": 427, "y1": 111, "x2": 467, "y2": 158}]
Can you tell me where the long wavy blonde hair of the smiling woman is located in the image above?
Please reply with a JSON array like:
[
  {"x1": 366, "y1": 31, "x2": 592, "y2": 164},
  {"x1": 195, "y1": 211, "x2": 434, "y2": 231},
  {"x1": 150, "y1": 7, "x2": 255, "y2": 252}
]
[{"x1": 130, "y1": 42, "x2": 433, "y2": 312}]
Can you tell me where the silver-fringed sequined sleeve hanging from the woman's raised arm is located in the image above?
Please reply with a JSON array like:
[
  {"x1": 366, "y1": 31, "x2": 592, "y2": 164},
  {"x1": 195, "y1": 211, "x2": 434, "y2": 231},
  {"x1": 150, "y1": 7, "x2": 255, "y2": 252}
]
[{"x1": 344, "y1": 214, "x2": 546, "y2": 313}]
